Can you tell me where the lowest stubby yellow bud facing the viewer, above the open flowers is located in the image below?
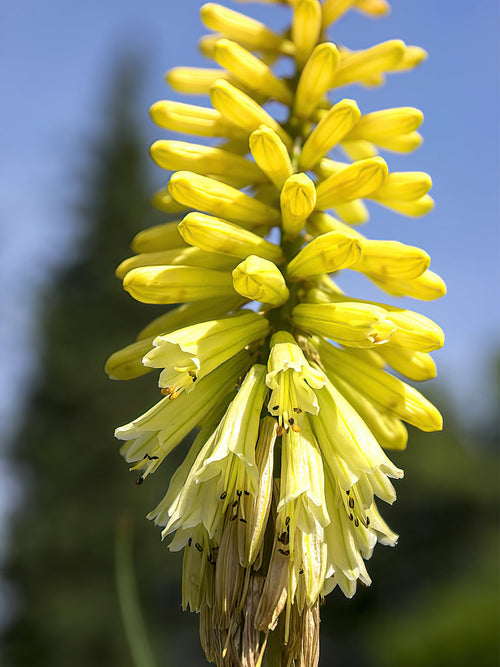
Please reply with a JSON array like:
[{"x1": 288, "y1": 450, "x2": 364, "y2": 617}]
[{"x1": 233, "y1": 255, "x2": 290, "y2": 307}]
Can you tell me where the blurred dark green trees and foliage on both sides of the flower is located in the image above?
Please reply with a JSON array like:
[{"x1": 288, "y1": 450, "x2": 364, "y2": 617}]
[{"x1": 0, "y1": 31, "x2": 499, "y2": 667}]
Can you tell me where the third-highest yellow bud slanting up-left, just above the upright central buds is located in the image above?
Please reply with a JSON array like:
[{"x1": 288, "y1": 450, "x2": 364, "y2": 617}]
[{"x1": 210, "y1": 79, "x2": 292, "y2": 148}]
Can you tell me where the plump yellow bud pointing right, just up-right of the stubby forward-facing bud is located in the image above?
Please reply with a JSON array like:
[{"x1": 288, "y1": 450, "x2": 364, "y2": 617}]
[{"x1": 286, "y1": 232, "x2": 361, "y2": 281}]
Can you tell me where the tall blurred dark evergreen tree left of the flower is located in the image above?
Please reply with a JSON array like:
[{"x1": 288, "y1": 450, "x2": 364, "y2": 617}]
[{"x1": 0, "y1": 58, "x2": 202, "y2": 667}]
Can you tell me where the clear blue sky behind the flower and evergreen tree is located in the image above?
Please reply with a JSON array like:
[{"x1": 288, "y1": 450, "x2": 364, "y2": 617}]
[{"x1": 0, "y1": 0, "x2": 500, "y2": 560}]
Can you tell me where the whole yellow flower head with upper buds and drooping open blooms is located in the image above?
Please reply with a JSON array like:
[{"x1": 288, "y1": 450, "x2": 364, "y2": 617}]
[{"x1": 106, "y1": 0, "x2": 446, "y2": 667}]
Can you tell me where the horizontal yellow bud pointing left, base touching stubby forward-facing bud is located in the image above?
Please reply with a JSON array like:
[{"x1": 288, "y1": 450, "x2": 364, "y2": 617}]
[{"x1": 123, "y1": 266, "x2": 234, "y2": 303}]
